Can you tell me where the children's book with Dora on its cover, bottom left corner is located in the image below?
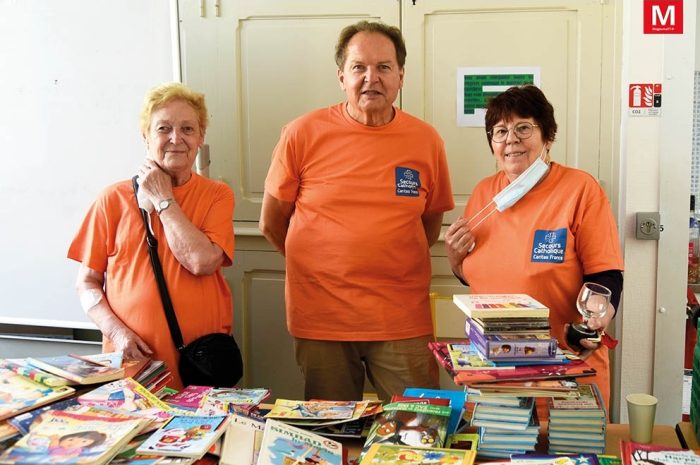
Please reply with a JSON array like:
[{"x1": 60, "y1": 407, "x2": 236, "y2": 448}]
[{"x1": 0, "y1": 410, "x2": 144, "y2": 465}]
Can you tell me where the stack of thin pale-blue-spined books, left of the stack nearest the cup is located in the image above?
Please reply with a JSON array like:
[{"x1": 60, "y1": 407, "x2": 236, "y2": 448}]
[{"x1": 471, "y1": 397, "x2": 540, "y2": 458}]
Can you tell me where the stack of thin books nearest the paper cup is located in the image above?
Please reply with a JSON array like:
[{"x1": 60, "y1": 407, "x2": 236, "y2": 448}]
[{"x1": 548, "y1": 384, "x2": 607, "y2": 454}]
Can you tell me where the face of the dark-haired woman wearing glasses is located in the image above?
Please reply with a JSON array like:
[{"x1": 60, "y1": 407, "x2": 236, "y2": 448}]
[{"x1": 491, "y1": 115, "x2": 549, "y2": 182}]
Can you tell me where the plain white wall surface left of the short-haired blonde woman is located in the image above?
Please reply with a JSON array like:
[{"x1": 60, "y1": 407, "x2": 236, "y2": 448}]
[{"x1": 0, "y1": 0, "x2": 179, "y2": 328}]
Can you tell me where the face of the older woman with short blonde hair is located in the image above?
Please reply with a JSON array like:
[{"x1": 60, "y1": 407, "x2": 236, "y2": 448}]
[{"x1": 144, "y1": 100, "x2": 204, "y2": 176}]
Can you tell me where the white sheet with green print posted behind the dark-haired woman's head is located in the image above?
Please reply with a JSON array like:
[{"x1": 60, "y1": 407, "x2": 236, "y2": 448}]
[{"x1": 457, "y1": 67, "x2": 540, "y2": 128}]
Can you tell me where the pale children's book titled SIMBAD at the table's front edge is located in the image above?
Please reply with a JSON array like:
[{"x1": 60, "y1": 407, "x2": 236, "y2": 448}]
[{"x1": 257, "y1": 419, "x2": 343, "y2": 465}]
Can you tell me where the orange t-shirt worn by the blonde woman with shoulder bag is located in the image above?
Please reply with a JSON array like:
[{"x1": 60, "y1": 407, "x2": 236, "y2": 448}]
[{"x1": 68, "y1": 173, "x2": 234, "y2": 389}]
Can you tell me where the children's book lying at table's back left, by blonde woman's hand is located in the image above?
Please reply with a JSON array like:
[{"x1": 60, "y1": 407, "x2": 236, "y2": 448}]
[{"x1": 27, "y1": 355, "x2": 124, "y2": 384}]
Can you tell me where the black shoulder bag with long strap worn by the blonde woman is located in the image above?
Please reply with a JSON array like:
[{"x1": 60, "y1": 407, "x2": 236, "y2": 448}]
[{"x1": 131, "y1": 176, "x2": 243, "y2": 387}]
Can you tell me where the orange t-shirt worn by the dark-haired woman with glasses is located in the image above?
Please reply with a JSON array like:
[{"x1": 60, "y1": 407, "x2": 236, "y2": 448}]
[{"x1": 462, "y1": 163, "x2": 623, "y2": 405}]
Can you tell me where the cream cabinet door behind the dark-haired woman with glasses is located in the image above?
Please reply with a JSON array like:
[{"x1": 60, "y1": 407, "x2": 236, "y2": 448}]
[{"x1": 402, "y1": 0, "x2": 614, "y2": 222}]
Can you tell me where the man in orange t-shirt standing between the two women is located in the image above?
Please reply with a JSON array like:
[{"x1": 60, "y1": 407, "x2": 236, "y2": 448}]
[{"x1": 260, "y1": 21, "x2": 454, "y2": 400}]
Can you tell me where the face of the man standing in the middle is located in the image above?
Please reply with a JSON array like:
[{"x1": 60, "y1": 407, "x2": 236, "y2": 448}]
[{"x1": 338, "y1": 32, "x2": 404, "y2": 126}]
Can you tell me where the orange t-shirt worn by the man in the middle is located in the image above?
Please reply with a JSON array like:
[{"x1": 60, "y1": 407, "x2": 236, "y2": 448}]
[{"x1": 265, "y1": 103, "x2": 454, "y2": 341}]
